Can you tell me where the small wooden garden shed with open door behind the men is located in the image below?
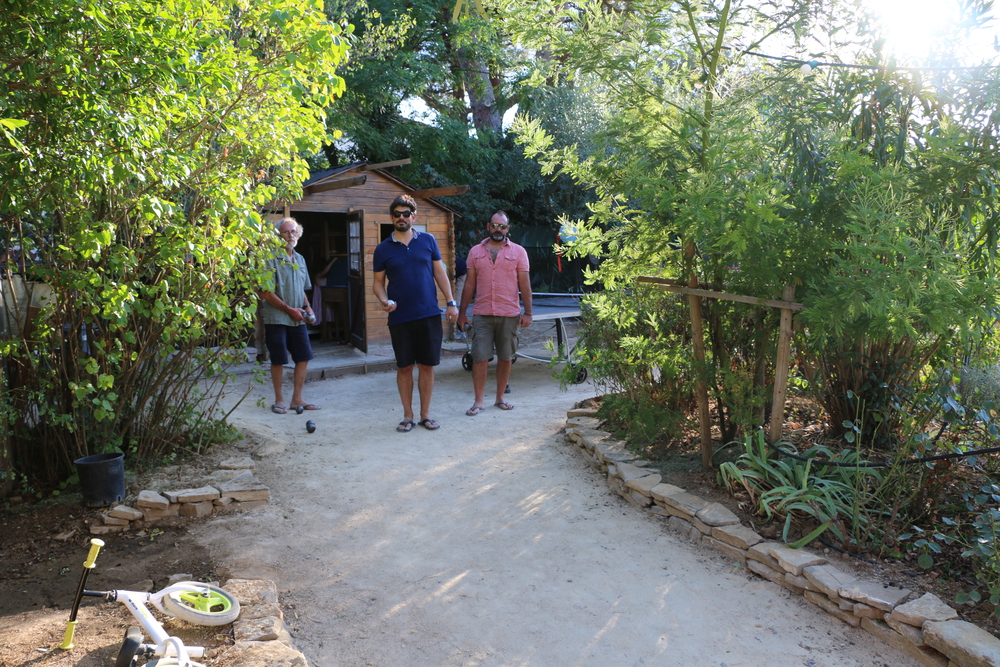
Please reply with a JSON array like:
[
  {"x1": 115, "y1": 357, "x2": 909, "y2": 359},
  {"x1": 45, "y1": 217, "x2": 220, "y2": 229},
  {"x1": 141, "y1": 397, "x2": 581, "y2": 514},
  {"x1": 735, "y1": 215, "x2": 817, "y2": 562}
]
[{"x1": 268, "y1": 160, "x2": 468, "y2": 353}]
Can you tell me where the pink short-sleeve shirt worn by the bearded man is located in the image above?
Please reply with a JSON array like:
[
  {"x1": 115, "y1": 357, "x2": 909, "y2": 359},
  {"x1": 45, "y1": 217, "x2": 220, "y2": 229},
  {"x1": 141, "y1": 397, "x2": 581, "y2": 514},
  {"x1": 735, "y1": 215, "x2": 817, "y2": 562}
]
[{"x1": 466, "y1": 239, "x2": 528, "y2": 317}]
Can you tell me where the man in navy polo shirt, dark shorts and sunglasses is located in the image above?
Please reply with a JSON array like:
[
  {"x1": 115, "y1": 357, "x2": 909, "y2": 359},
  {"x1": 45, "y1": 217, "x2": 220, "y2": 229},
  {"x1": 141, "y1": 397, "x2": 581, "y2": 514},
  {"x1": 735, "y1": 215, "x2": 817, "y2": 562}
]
[{"x1": 372, "y1": 195, "x2": 458, "y2": 433}]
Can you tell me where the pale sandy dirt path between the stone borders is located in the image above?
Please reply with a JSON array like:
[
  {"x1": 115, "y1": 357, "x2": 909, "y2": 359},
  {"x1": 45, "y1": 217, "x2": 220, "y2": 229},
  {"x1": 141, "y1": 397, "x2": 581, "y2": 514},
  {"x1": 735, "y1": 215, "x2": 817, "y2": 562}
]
[{"x1": 194, "y1": 357, "x2": 913, "y2": 667}]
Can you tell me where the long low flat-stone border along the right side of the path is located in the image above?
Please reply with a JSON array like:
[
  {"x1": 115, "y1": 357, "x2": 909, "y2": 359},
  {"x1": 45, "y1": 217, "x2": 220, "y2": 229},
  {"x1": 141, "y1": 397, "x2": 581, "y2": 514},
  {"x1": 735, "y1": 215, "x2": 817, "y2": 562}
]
[{"x1": 566, "y1": 407, "x2": 1000, "y2": 667}]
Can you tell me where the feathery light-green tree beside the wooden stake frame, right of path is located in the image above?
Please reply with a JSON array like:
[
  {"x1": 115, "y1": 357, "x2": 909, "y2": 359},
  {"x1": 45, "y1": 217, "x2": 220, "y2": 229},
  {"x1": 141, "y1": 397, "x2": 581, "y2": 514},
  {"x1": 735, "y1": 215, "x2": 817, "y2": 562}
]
[{"x1": 514, "y1": 3, "x2": 844, "y2": 448}]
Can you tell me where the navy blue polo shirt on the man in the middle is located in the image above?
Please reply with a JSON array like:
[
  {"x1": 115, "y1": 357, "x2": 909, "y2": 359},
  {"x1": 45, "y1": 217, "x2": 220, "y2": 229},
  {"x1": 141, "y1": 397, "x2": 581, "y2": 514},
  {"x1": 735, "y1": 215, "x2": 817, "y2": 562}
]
[{"x1": 372, "y1": 229, "x2": 441, "y2": 325}]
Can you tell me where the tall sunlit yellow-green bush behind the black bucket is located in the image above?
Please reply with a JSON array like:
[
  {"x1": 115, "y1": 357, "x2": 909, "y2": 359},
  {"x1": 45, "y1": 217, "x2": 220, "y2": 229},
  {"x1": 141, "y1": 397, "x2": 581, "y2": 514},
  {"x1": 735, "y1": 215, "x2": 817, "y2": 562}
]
[{"x1": 0, "y1": 0, "x2": 347, "y2": 483}]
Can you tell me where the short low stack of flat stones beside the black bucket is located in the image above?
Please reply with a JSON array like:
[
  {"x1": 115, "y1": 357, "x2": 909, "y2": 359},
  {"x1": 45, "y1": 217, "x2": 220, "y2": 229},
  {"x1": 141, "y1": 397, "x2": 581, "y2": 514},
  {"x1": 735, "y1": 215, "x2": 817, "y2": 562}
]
[{"x1": 90, "y1": 457, "x2": 271, "y2": 535}]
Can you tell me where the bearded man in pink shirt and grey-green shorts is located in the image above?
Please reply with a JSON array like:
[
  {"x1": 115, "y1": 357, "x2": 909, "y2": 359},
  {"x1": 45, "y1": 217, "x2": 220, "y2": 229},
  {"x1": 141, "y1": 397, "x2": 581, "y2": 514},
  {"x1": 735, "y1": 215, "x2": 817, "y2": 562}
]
[{"x1": 458, "y1": 211, "x2": 531, "y2": 417}]
